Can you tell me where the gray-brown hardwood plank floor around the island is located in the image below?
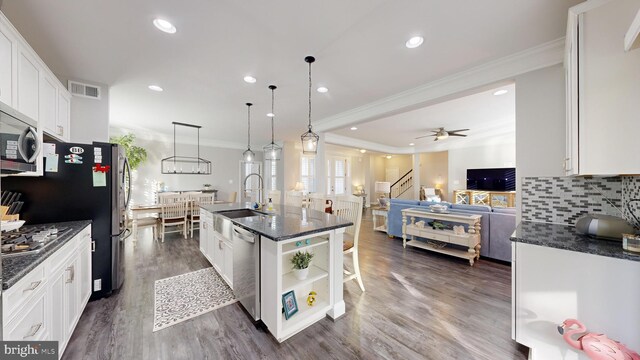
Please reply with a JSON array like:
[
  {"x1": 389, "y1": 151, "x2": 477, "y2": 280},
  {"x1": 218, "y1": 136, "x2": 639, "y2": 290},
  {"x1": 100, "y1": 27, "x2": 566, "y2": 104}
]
[{"x1": 63, "y1": 211, "x2": 526, "y2": 360}]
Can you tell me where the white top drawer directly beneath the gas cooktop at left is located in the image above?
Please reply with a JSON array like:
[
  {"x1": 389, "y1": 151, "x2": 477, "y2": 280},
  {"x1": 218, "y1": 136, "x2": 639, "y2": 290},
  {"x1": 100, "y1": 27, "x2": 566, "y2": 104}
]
[{"x1": 2, "y1": 264, "x2": 46, "y2": 323}]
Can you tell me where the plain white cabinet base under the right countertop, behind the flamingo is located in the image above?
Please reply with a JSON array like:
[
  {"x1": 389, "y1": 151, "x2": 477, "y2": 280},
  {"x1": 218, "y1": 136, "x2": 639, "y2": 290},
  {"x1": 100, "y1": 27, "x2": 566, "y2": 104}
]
[{"x1": 511, "y1": 242, "x2": 640, "y2": 360}]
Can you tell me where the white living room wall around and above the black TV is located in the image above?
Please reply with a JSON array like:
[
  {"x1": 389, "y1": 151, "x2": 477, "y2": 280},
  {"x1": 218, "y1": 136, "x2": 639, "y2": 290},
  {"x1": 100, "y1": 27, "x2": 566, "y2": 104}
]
[{"x1": 447, "y1": 142, "x2": 520, "y2": 201}]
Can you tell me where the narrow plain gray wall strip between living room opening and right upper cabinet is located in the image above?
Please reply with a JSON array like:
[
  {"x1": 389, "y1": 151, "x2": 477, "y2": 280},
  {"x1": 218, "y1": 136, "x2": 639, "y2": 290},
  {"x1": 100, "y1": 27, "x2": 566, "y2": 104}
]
[{"x1": 515, "y1": 64, "x2": 566, "y2": 222}]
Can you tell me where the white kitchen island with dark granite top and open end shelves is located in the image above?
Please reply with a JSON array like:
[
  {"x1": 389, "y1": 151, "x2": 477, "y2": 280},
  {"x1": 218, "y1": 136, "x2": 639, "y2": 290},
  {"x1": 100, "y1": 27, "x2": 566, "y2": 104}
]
[{"x1": 200, "y1": 203, "x2": 353, "y2": 342}]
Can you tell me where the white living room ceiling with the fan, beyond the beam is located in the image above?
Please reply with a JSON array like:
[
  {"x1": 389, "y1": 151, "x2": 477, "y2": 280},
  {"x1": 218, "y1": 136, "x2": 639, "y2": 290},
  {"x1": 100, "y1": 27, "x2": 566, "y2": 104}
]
[{"x1": 332, "y1": 84, "x2": 516, "y2": 152}]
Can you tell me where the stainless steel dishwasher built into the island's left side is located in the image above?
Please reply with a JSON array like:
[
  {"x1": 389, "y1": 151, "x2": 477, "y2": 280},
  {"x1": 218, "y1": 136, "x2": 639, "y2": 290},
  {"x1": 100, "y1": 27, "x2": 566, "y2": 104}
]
[{"x1": 233, "y1": 225, "x2": 260, "y2": 321}]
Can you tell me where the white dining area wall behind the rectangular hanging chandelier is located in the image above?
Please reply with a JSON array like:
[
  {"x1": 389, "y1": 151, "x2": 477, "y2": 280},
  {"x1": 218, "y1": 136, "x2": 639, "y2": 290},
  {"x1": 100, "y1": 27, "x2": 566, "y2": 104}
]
[{"x1": 111, "y1": 128, "x2": 262, "y2": 204}]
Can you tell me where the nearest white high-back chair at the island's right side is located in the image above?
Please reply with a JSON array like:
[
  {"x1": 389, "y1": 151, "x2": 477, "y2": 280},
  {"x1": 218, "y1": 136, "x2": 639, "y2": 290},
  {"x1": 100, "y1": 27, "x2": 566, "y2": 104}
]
[{"x1": 333, "y1": 195, "x2": 364, "y2": 291}]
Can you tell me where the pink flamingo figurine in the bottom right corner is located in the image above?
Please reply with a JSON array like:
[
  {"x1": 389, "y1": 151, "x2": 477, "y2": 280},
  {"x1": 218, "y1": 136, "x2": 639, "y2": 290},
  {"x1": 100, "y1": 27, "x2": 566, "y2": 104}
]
[{"x1": 558, "y1": 319, "x2": 640, "y2": 360}]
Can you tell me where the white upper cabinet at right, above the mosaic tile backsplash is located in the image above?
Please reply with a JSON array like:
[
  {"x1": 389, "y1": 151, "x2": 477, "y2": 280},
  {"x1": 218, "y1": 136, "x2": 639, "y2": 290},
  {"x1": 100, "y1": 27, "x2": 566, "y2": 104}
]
[{"x1": 565, "y1": 0, "x2": 640, "y2": 175}]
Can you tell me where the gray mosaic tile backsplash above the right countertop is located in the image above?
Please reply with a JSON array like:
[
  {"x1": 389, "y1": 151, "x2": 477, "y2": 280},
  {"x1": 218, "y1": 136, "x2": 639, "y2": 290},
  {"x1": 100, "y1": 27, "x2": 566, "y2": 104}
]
[{"x1": 521, "y1": 176, "x2": 640, "y2": 225}]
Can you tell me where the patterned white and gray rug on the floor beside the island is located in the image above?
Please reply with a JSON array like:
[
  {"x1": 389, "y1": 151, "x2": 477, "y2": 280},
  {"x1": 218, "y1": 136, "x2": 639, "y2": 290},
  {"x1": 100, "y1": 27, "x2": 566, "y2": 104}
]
[{"x1": 153, "y1": 267, "x2": 237, "y2": 331}]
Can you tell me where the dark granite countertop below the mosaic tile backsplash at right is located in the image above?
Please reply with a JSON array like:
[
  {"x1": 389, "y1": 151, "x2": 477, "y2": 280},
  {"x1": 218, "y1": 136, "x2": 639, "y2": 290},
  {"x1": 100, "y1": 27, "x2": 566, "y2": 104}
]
[{"x1": 511, "y1": 221, "x2": 640, "y2": 261}]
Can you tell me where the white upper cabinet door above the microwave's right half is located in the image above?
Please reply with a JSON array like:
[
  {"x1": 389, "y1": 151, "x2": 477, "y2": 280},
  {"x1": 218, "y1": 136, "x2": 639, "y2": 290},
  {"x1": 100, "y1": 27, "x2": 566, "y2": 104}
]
[{"x1": 17, "y1": 45, "x2": 40, "y2": 121}]
